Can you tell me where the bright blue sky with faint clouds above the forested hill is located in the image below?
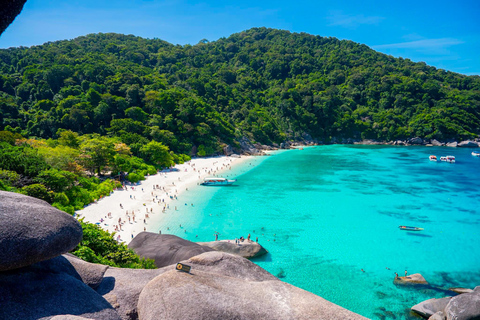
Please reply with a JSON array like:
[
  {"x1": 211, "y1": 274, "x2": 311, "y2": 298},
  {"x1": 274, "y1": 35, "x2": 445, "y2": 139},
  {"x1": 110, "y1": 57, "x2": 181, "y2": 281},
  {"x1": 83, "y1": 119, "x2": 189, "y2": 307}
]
[{"x1": 0, "y1": 0, "x2": 480, "y2": 75}]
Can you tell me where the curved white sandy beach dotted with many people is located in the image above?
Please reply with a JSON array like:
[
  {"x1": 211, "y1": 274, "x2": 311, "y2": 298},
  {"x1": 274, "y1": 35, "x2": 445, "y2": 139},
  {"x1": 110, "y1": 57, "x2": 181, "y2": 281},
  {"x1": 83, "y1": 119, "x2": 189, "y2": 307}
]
[{"x1": 76, "y1": 156, "x2": 251, "y2": 243}]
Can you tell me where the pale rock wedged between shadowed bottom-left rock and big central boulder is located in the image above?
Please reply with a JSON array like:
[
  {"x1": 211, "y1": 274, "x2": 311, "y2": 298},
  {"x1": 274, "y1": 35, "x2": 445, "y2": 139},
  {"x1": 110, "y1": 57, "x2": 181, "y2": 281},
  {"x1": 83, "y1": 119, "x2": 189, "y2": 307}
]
[{"x1": 96, "y1": 266, "x2": 166, "y2": 320}]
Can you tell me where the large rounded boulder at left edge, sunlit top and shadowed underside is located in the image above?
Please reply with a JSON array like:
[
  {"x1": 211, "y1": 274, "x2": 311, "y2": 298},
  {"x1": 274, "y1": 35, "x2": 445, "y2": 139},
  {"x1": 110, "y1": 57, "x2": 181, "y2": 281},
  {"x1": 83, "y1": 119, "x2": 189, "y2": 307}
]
[{"x1": 0, "y1": 191, "x2": 82, "y2": 271}]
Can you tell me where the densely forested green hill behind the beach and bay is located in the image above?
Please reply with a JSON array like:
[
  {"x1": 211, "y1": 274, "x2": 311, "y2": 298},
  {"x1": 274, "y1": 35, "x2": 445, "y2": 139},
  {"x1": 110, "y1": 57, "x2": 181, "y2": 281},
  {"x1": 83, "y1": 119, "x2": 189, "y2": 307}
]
[{"x1": 0, "y1": 28, "x2": 480, "y2": 155}]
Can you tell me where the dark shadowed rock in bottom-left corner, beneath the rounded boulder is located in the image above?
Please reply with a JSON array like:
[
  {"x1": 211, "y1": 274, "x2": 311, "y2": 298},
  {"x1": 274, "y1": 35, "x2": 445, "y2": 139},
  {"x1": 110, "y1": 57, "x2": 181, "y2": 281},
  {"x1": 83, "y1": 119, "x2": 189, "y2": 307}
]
[{"x1": 0, "y1": 257, "x2": 120, "y2": 320}]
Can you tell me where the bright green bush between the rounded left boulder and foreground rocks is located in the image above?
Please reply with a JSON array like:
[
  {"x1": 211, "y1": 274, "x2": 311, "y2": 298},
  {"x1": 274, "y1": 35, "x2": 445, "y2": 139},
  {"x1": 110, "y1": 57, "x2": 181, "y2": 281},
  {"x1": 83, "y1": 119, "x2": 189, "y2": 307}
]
[{"x1": 73, "y1": 220, "x2": 156, "y2": 269}]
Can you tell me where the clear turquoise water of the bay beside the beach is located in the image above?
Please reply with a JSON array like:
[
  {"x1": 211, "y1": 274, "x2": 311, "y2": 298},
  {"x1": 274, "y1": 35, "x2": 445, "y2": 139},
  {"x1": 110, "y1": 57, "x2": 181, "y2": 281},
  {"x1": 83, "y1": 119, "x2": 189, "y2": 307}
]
[{"x1": 157, "y1": 145, "x2": 480, "y2": 319}]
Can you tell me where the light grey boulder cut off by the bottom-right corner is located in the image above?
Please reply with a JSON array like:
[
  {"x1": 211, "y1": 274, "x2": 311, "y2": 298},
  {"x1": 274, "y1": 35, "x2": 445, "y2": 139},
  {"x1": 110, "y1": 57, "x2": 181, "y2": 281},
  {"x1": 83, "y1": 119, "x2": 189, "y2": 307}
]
[{"x1": 444, "y1": 287, "x2": 480, "y2": 320}]
